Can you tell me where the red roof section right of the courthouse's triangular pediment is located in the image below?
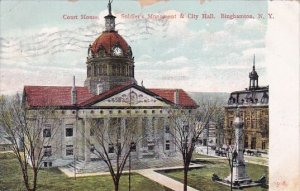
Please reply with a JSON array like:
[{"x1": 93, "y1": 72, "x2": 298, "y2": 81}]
[{"x1": 149, "y1": 89, "x2": 197, "y2": 107}]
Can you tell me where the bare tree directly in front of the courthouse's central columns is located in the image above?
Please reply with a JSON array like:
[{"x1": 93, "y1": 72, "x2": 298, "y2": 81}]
[{"x1": 87, "y1": 117, "x2": 142, "y2": 191}]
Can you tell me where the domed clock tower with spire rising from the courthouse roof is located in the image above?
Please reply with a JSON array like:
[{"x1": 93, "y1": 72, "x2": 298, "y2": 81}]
[{"x1": 84, "y1": 1, "x2": 136, "y2": 94}]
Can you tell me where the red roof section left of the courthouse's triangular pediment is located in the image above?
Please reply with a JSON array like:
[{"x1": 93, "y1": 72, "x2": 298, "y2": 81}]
[{"x1": 24, "y1": 86, "x2": 94, "y2": 107}]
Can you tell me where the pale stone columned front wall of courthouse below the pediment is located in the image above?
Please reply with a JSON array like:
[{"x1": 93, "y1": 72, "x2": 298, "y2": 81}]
[{"x1": 31, "y1": 100, "x2": 195, "y2": 166}]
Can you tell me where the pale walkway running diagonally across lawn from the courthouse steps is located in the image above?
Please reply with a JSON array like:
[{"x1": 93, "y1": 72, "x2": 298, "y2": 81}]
[{"x1": 136, "y1": 169, "x2": 198, "y2": 191}]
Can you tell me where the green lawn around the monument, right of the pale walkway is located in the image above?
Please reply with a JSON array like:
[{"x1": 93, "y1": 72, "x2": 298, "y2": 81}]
[{"x1": 162, "y1": 159, "x2": 268, "y2": 191}]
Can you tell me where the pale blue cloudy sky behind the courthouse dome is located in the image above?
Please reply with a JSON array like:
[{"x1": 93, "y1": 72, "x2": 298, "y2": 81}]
[{"x1": 0, "y1": 0, "x2": 268, "y2": 94}]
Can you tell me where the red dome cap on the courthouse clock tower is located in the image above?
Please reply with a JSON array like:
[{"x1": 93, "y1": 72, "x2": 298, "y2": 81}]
[{"x1": 91, "y1": 31, "x2": 131, "y2": 54}]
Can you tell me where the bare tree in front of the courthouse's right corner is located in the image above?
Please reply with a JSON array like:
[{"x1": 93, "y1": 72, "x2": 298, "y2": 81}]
[{"x1": 169, "y1": 101, "x2": 217, "y2": 191}]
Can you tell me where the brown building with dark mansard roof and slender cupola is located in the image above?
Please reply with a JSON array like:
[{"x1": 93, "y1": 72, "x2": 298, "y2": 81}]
[{"x1": 224, "y1": 57, "x2": 269, "y2": 150}]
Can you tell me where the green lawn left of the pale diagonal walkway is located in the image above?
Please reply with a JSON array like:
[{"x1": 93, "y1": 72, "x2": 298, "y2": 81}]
[{"x1": 0, "y1": 153, "x2": 169, "y2": 191}]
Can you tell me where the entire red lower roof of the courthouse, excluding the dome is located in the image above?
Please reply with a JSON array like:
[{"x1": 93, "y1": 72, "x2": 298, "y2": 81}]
[{"x1": 24, "y1": 84, "x2": 197, "y2": 107}]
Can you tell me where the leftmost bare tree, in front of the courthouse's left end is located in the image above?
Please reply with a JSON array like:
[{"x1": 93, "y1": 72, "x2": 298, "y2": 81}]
[{"x1": 0, "y1": 94, "x2": 57, "y2": 191}]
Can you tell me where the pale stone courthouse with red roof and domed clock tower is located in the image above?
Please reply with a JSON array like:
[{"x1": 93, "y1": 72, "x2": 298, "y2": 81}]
[{"x1": 23, "y1": 1, "x2": 198, "y2": 166}]
